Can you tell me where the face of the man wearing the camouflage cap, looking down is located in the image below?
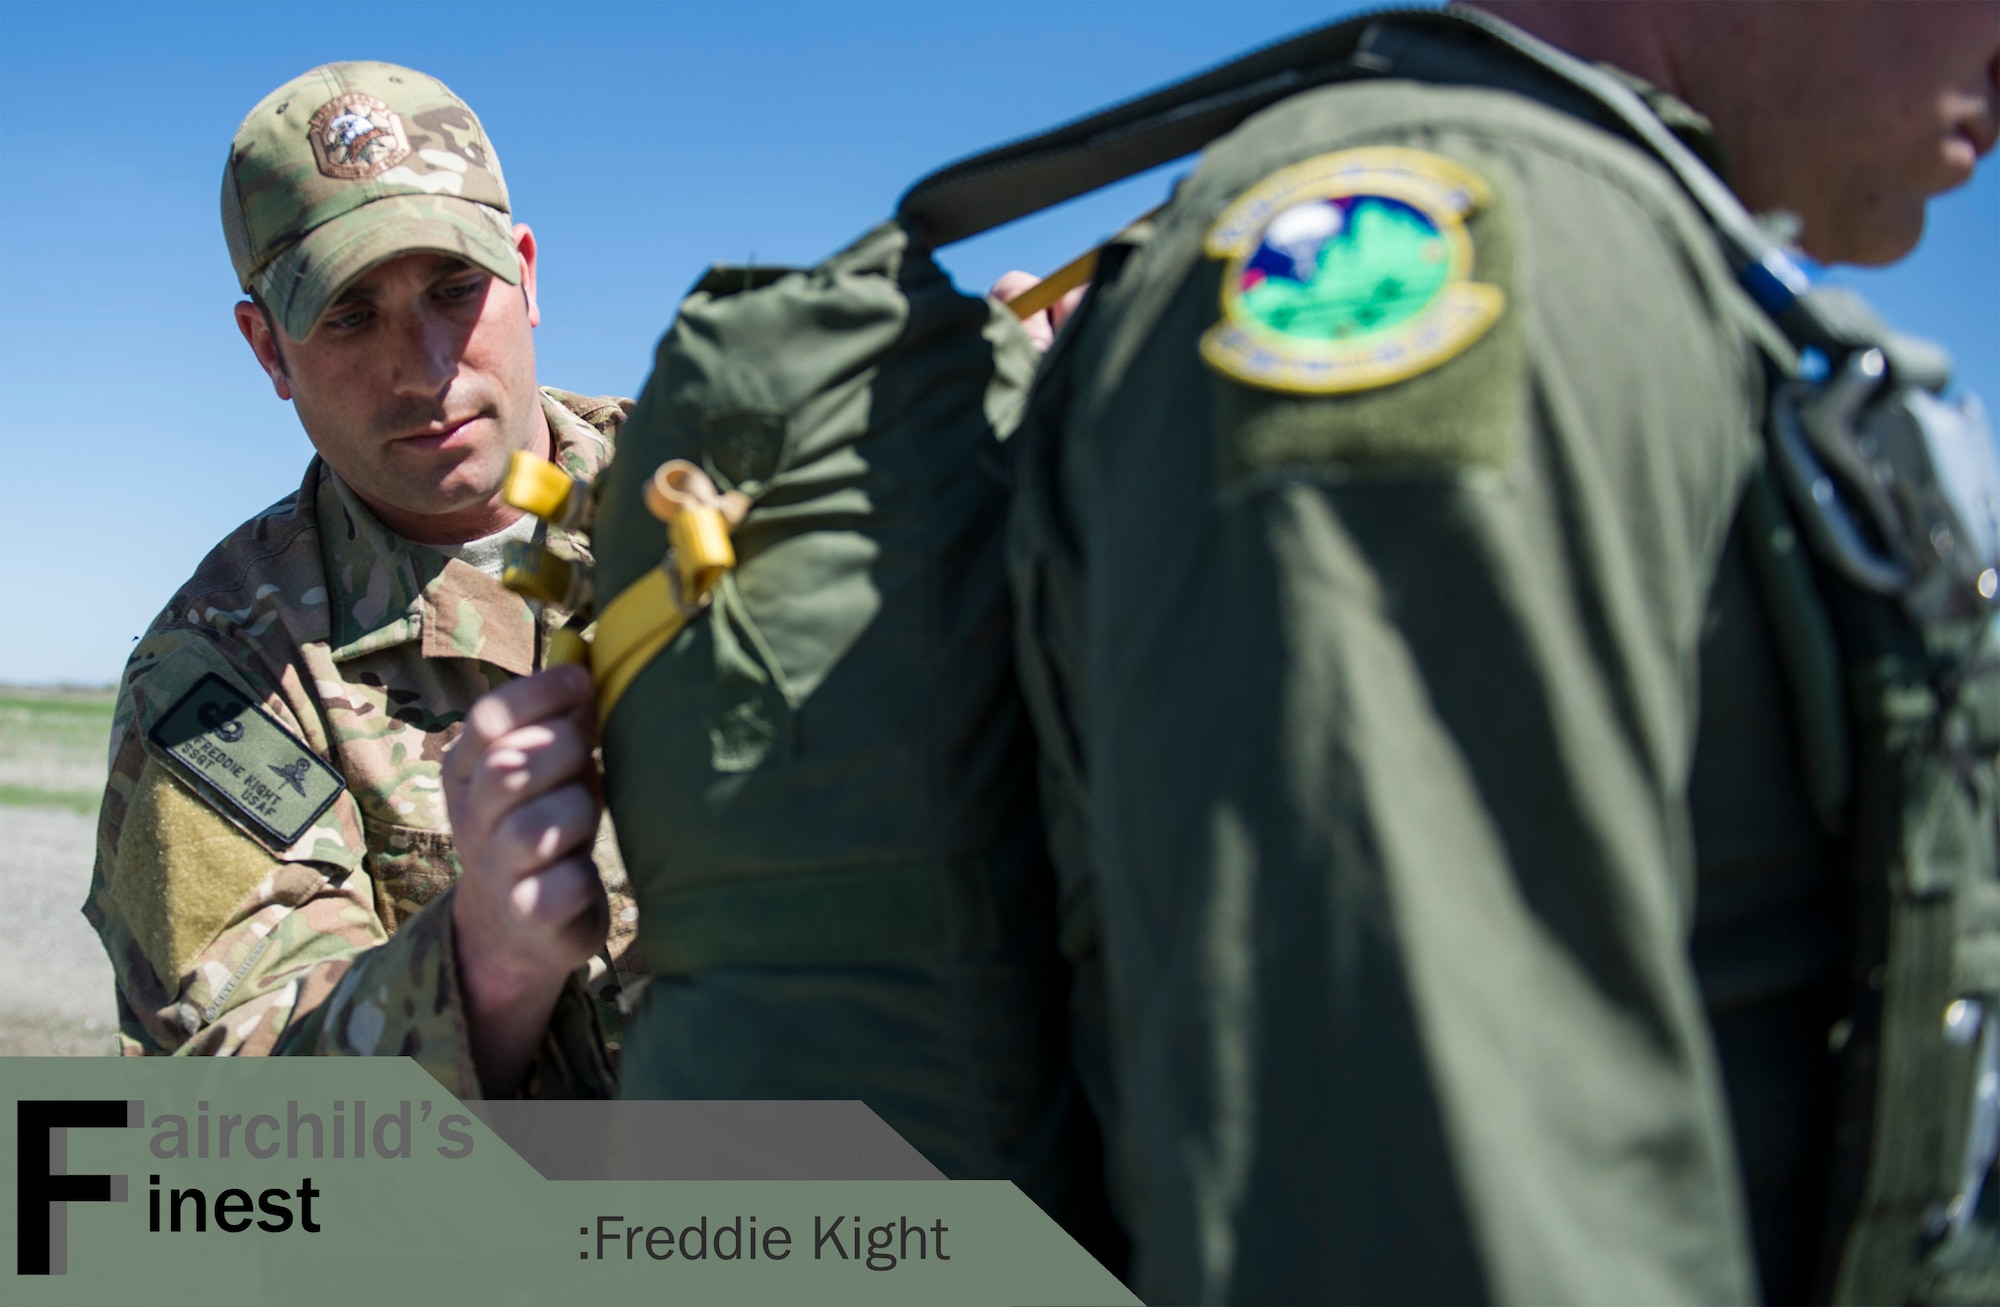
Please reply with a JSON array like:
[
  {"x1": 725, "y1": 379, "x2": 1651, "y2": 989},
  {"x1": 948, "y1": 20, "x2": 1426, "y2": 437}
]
[{"x1": 236, "y1": 226, "x2": 548, "y2": 544}]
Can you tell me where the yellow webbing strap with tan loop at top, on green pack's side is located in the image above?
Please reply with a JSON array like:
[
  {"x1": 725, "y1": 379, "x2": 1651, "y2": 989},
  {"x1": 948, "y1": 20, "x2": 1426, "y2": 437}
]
[{"x1": 590, "y1": 458, "x2": 750, "y2": 721}]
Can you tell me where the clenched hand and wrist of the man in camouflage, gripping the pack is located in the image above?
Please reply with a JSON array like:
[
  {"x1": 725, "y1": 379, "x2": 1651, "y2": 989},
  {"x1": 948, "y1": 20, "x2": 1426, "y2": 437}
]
[{"x1": 444, "y1": 667, "x2": 610, "y2": 1095}]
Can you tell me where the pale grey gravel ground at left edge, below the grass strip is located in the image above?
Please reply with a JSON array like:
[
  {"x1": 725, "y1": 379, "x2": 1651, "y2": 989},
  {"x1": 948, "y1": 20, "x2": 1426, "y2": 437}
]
[{"x1": 0, "y1": 807, "x2": 118, "y2": 1057}]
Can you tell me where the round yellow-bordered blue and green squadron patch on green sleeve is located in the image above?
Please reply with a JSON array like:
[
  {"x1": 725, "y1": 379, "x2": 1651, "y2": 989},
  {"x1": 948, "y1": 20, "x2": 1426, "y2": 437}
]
[{"x1": 1202, "y1": 146, "x2": 1506, "y2": 396}]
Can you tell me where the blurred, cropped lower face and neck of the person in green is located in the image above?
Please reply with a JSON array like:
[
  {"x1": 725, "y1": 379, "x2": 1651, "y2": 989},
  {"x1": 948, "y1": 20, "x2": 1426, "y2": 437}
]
[{"x1": 1690, "y1": 0, "x2": 2000, "y2": 264}]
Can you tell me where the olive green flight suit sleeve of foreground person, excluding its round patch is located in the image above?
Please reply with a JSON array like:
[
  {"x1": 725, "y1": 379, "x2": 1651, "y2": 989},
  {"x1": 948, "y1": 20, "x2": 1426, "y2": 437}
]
[{"x1": 1010, "y1": 82, "x2": 1760, "y2": 1303}]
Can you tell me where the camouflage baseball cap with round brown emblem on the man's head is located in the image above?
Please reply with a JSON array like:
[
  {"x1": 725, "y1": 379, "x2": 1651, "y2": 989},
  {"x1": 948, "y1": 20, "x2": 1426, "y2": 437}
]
[{"x1": 222, "y1": 62, "x2": 520, "y2": 340}]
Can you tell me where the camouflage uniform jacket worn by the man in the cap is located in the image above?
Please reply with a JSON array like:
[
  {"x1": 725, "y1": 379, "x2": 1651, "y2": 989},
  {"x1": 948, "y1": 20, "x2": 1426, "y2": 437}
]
[{"x1": 84, "y1": 390, "x2": 636, "y2": 1097}]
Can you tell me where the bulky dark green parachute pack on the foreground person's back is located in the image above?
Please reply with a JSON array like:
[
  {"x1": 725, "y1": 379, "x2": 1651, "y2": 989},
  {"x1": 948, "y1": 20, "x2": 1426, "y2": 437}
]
[{"x1": 594, "y1": 224, "x2": 1128, "y2": 1249}]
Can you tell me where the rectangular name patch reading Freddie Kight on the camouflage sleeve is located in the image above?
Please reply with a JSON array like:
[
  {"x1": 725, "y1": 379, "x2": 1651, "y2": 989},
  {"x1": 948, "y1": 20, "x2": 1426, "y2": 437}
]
[{"x1": 148, "y1": 671, "x2": 346, "y2": 847}]
